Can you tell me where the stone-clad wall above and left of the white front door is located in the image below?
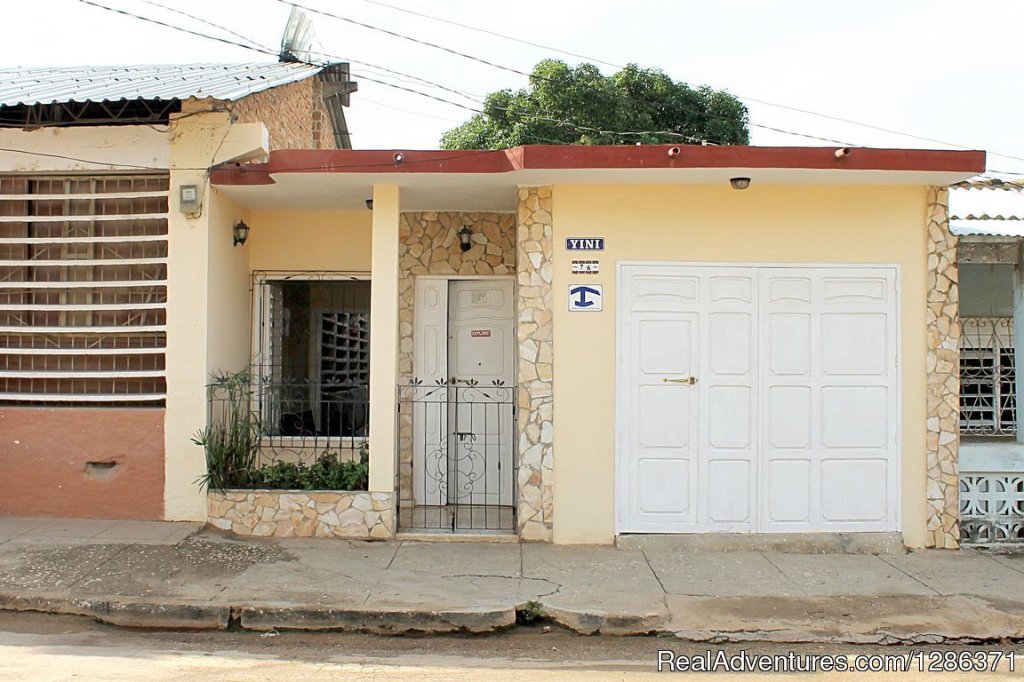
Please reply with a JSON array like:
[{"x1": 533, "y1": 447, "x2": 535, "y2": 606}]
[{"x1": 398, "y1": 211, "x2": 516, "y2": 504}]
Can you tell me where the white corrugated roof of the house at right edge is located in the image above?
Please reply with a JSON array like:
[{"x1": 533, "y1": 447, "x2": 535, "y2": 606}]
[{"x1": 949, "y1": 178, "x2": 1024, "y2": 237}]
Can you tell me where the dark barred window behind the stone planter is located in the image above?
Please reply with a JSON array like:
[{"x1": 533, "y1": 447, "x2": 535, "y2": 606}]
[{"x1": 254, "y1": 273, "x2": 370, "y2": 440}]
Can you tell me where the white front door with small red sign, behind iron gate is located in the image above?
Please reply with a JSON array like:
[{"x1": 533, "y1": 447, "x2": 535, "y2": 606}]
[{"x1": 413, "y1": 278, "x2": 515, "y2": 506}]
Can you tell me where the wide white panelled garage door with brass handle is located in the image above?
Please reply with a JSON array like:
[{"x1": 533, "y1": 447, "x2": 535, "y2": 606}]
[{"x1": 616, "y1": 262, "x2": 900, "y2": 532}]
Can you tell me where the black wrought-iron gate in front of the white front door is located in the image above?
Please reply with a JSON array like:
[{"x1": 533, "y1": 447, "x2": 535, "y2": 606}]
[{"x1": 397, "y1": 378, "x2": 516, "y2": 532}]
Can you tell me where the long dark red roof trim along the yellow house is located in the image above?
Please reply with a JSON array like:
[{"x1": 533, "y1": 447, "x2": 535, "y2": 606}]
[{"x1": 211, "y1": 144, "x2": 985, "y2": 185}]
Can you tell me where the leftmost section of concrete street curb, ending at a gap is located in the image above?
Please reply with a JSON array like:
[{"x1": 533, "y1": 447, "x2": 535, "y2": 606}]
[{"x1": 0, "y1": 594, "x2": 231, "y2": 630}]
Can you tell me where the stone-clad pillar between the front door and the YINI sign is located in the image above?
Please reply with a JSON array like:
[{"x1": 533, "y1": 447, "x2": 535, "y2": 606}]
[{"x1": 516, "y1": 187, "x2": 554, "y2": 542}]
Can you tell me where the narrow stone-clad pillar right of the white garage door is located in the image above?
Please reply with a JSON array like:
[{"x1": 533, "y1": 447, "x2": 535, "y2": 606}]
[{"x1": 926, "y1": 187, "x2": 961, "y2": 549}]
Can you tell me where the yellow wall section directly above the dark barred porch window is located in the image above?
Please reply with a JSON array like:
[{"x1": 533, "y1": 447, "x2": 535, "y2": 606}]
[{"x1": 246, "y1": 210, "x2": 374, "y2": 272}]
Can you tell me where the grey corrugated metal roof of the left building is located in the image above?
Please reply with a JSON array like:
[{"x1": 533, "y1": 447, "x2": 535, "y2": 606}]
[{"x1": 0, "y1": 61, "x2": 323, "y2": 106}]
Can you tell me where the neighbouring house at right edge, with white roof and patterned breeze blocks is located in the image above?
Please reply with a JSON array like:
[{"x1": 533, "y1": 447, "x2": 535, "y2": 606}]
[{"x1": 949, "y1": 178, "x2": 1024, "y2": 544}]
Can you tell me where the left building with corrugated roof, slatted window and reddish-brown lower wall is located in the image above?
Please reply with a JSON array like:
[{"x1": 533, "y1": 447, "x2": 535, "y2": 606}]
[{"x1": 0, "y1": 62, "x2": 355, "y2": 518}]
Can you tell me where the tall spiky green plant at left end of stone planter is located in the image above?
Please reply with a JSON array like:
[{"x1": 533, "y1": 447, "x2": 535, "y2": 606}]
[{"x1": 191, "y1": 370, "x2": 263, "y2": 491}]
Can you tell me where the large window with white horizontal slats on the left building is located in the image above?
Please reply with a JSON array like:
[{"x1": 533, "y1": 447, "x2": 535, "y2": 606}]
[{"x1": 0, "y1": 174, "x2": 168, "y2": 406}]
